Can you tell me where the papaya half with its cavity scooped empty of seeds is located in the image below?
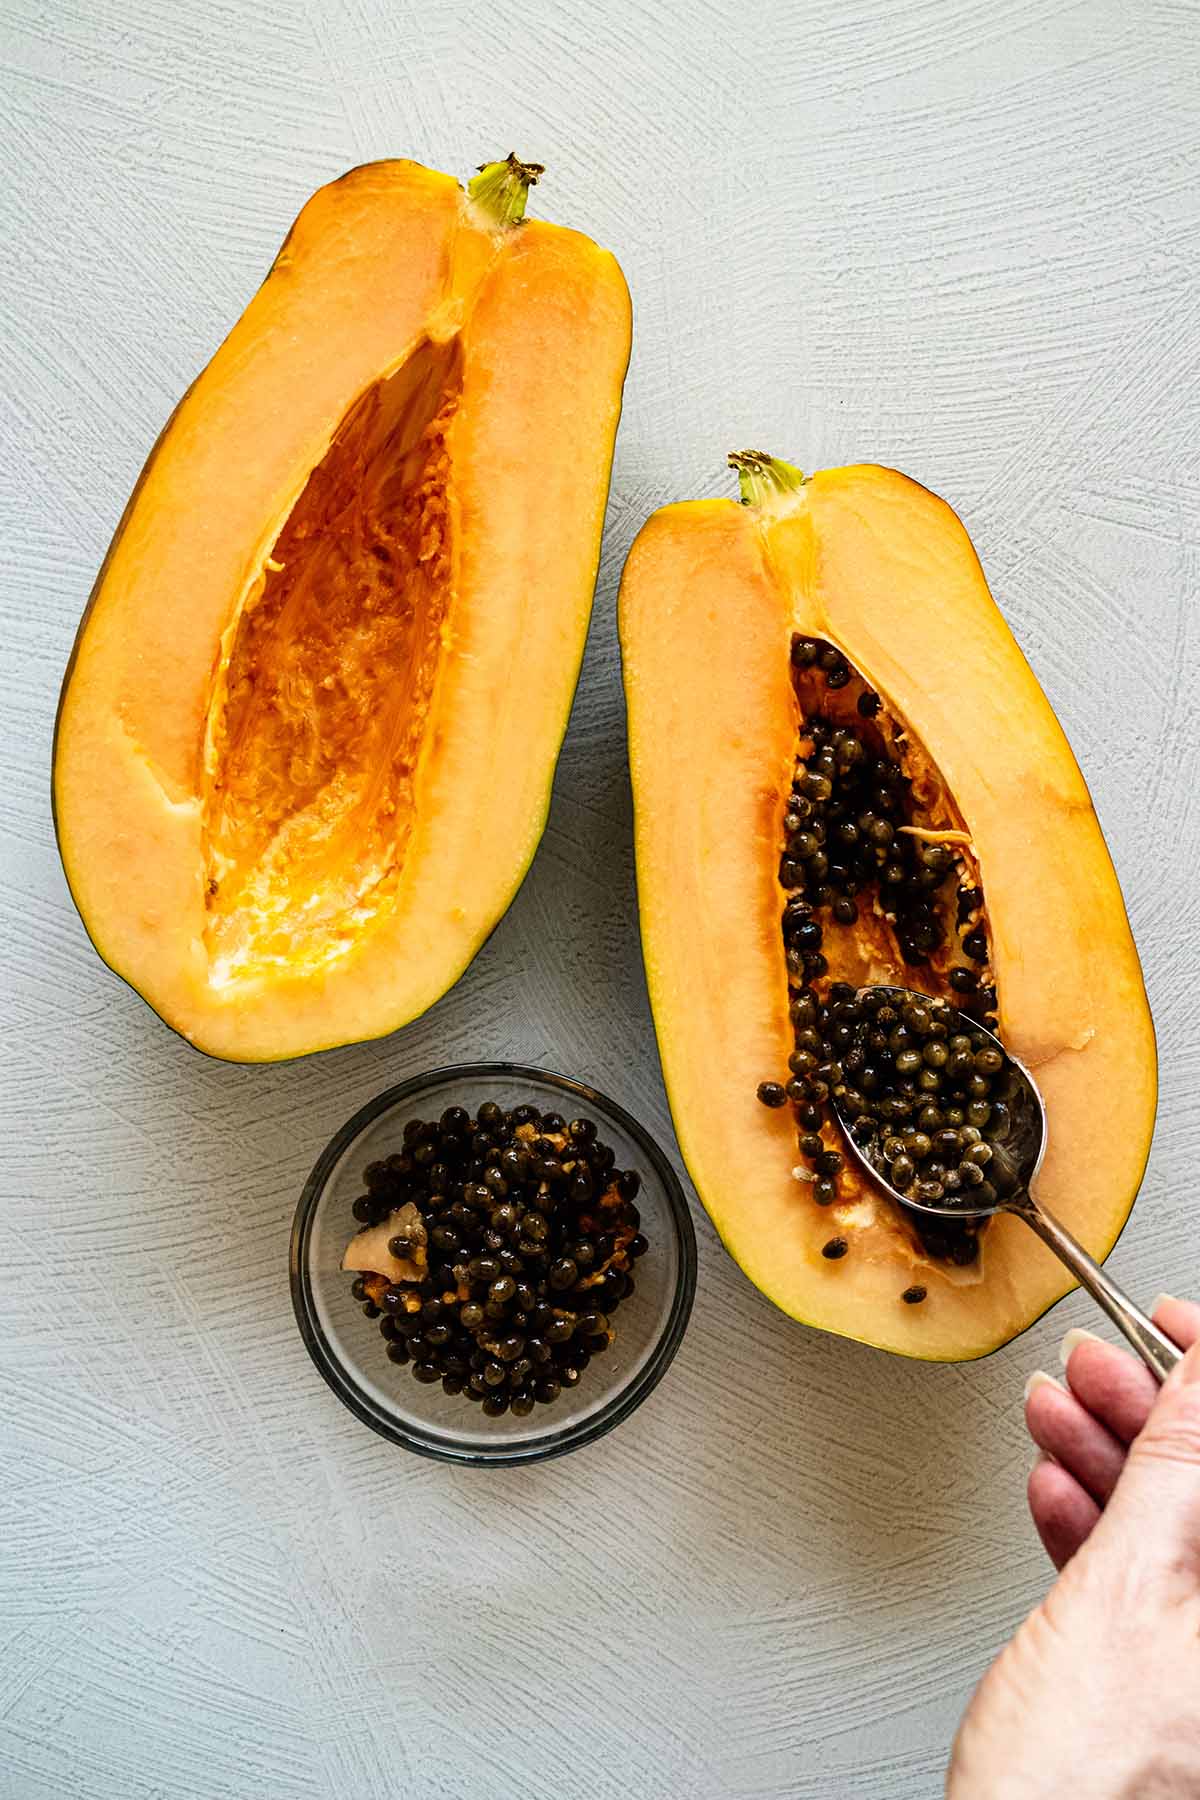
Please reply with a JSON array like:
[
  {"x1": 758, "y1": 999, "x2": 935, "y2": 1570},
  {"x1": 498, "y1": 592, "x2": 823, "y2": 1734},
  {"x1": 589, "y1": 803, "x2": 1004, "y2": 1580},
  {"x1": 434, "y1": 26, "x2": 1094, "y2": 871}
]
[{"x1": 54, "y1": 157, "x2": 630, "y2": 1062}]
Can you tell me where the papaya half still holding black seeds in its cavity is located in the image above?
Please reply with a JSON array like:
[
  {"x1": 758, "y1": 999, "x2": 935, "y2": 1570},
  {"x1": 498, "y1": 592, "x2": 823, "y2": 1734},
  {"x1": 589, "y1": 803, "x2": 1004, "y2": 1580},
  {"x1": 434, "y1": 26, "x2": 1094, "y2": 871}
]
[{"x1": 621, "y1": 452, "x2": 1157, "y2": 1361}]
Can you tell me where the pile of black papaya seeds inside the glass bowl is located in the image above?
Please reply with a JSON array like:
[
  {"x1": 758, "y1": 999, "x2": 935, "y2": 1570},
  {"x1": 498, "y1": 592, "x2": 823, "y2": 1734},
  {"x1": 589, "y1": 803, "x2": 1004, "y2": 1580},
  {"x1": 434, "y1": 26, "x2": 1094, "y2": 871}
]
[{"x1": 342, "y1": 1102, "x2": 649, "y2": 1418}]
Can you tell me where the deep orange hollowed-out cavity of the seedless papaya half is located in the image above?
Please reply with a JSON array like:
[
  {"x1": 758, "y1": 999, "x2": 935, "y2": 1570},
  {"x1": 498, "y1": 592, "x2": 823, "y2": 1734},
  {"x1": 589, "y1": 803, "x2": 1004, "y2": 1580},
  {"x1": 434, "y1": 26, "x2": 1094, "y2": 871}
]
[{"x1": 203, "y1": 340, "x2": 461, "y2": 985}]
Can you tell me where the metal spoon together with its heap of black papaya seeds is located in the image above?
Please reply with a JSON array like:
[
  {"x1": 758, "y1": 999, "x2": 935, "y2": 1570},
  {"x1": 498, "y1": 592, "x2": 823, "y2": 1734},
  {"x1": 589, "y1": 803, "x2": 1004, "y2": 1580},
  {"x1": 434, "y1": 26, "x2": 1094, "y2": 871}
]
[{"x1": 831, "y1": 986, "x2": 1182, "y2": 1381}]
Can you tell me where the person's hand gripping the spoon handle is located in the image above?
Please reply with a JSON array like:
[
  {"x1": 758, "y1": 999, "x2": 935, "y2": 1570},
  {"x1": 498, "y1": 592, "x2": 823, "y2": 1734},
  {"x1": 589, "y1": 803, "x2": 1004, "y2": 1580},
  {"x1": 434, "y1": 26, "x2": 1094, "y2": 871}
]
[{"x1": 946, "y1": 1300, "x2": 1200, "y2": 1800}]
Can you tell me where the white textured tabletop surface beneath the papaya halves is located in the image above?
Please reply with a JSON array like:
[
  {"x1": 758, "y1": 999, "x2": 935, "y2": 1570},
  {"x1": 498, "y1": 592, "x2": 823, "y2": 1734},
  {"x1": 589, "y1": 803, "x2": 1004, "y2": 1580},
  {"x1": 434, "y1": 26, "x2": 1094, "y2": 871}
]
[{"x1": 0, "y1": 0, "x2": 1200, "y2": 1800}]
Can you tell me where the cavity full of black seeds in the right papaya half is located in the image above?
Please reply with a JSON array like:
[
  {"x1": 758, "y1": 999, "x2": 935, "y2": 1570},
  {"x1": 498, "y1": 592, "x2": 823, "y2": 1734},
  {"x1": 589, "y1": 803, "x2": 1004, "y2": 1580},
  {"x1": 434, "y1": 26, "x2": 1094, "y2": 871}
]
[{"x1": 757, "y1": 635, "x2": 1004, "y2": 1267}]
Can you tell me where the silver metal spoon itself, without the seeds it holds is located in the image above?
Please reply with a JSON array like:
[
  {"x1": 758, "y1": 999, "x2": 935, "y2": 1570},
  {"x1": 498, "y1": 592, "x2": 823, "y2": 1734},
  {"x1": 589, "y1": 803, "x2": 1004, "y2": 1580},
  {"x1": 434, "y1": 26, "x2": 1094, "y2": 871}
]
[{"x1": 833, "y1": 986, "x2": 1184, "y2": 1381}]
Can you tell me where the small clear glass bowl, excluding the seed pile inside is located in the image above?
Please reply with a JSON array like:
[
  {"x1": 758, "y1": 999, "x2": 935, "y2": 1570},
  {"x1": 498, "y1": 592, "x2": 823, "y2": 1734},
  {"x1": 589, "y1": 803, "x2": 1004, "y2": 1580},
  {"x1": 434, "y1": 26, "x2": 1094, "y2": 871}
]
[{"x1": 291, "y1": 1062, "x2": 696, "y2": 1463}]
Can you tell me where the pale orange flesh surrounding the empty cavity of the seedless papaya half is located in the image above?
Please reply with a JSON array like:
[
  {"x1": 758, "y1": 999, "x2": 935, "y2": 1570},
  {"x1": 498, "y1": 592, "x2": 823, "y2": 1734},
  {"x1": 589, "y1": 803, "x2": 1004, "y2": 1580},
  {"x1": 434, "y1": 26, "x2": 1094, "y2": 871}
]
[{"x1": 52, "y1": 158, "x2": 630, "y2": 1062}]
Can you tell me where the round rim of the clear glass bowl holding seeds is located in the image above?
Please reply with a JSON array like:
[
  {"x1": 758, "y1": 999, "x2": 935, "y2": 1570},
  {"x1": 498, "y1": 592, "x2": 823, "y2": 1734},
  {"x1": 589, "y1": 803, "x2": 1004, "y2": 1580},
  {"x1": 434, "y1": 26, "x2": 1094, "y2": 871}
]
[{"x1": 288, "y1": 1060, "x2": 696, "y2": 1467}]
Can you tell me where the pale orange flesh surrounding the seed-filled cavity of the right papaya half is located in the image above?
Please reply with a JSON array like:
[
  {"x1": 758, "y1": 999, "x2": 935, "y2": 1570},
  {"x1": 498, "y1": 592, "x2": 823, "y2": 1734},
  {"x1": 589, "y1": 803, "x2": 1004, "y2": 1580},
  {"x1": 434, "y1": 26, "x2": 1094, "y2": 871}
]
[{"x1": 621, "y1": 466, "x2": 1155, "y2": 1361}]
